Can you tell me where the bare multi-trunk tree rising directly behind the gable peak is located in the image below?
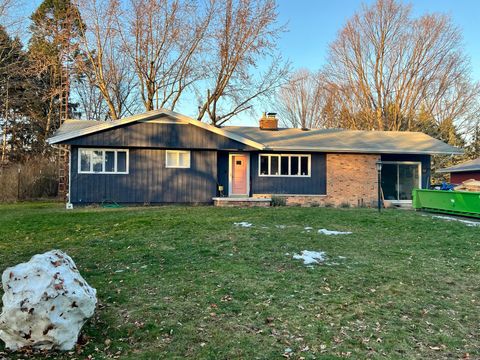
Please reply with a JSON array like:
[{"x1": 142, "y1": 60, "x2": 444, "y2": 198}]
[{"x1": 119, "y1": 0, "x2": 214, "y2": 111}]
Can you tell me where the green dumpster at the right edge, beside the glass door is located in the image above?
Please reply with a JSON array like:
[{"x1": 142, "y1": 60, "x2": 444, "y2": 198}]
[{"x1": 412, "y1": 189, "x2": 480, "y2": 218}]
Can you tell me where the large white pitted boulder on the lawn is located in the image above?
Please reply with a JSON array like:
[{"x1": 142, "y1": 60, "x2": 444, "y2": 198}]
[{"x1": 0, "y1": 250, "x2": 97, "y2": 350}]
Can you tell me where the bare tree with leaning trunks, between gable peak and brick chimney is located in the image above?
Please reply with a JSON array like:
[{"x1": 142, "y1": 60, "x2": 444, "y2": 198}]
[{"x1": 197, "y1": 0, "x2": 288, "y2": 126}]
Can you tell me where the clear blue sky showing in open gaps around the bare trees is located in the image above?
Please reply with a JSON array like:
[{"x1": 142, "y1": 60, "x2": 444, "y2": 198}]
[{"x1": 8, "y1": 0, "x2": 480, "y2": 125}]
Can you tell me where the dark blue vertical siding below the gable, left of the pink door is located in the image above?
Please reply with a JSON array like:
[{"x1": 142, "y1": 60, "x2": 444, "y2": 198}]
[{"x1": 70, "y1": 147, "x2": 217, "y2": 204}]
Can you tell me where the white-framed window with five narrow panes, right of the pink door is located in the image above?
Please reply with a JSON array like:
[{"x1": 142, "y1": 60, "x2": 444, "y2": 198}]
[{"x1": 258, "y1": 154, "x2": 312, "y2": 177}]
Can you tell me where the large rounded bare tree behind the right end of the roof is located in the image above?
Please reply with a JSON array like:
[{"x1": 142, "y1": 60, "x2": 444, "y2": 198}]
[{"x1": 325, "y1": 0, "x2": 480, "y2": 130}]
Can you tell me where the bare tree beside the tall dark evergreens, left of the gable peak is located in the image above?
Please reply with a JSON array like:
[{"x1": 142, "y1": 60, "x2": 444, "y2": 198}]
[{"x1": 74, "y1": 0, "x2": 136, "y2": 120}]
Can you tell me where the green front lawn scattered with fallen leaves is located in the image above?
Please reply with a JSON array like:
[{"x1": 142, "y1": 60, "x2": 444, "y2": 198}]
[{"x1": 0, "y1": 203, "x2": 480, "y2": 359}]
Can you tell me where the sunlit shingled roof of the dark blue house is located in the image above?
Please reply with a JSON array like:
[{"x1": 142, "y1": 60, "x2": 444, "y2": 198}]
[{"x1": 49, "y1": 109, "x2": 463, "y2": 154}]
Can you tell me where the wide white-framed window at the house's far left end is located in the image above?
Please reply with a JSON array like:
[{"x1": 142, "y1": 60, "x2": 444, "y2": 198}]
[{"x1": 78, "y1": 148, "x2": 128, "y2": 174}]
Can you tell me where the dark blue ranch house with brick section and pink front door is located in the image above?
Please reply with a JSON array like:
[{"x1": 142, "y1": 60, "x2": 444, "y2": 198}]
[{"x1": 49, "y1": 110, "x2": 461, "y2": 206}]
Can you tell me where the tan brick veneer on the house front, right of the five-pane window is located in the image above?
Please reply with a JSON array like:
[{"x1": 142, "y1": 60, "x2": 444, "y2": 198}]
[{"x1": 254, "y1": 154, "x2": 380, "y2": 207}]
